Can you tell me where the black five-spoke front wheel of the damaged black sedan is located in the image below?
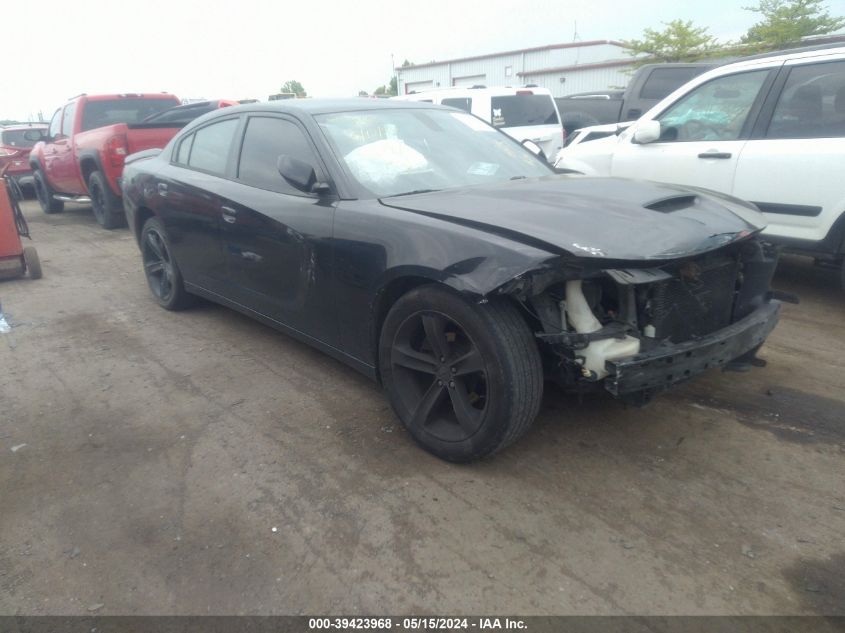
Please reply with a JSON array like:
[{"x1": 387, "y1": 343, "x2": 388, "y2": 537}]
[{"x1": 379, "y1": 285, "x2": 543, "y2": 462}]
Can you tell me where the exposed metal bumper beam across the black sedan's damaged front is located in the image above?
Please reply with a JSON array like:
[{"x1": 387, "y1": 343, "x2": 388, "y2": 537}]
[{"x1": 604, "y1": 301, "x2": 780, "y2": 397}]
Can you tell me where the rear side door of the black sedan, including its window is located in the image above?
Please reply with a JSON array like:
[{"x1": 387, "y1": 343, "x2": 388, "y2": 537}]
[{"x1": 154, "y1": 117, "x2": 240, "y2": 293}]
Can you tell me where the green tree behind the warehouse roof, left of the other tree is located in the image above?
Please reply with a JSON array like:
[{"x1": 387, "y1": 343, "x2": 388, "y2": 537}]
[{"x1": 623, "y1": 19, "x2": 720, "y2": 66}]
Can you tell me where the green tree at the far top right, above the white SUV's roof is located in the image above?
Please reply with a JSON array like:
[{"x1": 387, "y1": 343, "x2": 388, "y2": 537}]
[{"x1": 742, "y1": 0, "x2": 845, "y2": 50}]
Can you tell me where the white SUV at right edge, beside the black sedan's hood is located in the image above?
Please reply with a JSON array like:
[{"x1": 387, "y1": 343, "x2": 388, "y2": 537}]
[{"x1": 556, "y1": 47, "x2": 845, "y2": 284}]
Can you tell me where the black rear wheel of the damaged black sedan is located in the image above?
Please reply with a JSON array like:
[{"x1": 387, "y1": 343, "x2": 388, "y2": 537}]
[{"x1": 141, "y1": 218, "x2": 194, "y2": 310}]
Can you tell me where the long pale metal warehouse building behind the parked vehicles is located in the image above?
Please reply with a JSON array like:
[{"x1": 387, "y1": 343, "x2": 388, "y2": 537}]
[{"x1": 396, "y1": 40, "x2": 632, "y2": 97}]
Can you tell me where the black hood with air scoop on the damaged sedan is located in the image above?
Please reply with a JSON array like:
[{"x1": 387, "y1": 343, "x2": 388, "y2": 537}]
[{"x1": 381, "y1": 176, "x2": 766, "y2": 262}]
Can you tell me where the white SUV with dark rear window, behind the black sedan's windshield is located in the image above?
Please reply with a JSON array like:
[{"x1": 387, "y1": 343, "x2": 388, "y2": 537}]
[{"x1": 394, "y1": 86, "x2": 565, "y2": 161}]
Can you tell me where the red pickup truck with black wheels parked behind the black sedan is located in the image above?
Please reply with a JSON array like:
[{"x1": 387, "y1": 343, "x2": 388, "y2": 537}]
[{"x1": 29, "y1": 93, "x2": 180, "y2": 229}]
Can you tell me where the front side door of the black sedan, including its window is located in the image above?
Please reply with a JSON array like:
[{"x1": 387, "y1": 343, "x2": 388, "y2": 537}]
[{"x1": 216, "y1": 113, "x2": 336, "y2": 345}]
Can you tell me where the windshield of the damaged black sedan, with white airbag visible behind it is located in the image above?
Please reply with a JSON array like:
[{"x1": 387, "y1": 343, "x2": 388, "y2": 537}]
[{"x1": 315, "y1": 109, "x2": 552, "y2": 197}]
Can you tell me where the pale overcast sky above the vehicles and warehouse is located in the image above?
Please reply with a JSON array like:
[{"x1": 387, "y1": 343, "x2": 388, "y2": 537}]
[{"x1": 0, "y1": 0, "x2": 845, "y2": 120}]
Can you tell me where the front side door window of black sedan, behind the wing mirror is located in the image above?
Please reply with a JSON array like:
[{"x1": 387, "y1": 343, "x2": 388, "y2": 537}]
[{"x1": 238, "y1": 117, "x2": 317, "y2": 194}]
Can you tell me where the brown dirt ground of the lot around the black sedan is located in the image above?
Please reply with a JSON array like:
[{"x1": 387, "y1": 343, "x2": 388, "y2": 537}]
[{"x1": 0, "y1": 202, "x2": 845, "y2": 615}]
